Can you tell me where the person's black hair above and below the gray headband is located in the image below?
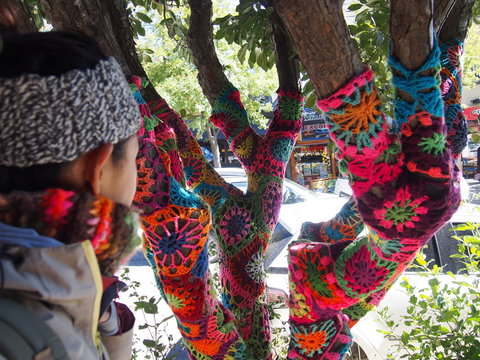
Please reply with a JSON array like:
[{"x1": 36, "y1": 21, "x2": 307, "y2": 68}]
[{"x1": 0, "y1": 31, "x2": 127, "y2": 193}]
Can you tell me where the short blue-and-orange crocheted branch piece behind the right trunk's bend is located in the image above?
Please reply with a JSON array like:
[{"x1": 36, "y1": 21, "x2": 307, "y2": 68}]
[{"x1": 299, "y1": 197, "x2": 364, "y2": 244}]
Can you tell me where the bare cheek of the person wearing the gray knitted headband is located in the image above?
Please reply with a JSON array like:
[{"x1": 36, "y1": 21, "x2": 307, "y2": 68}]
[{"x1": 100, "y1": 136, "x2": 138, "y2": 206}]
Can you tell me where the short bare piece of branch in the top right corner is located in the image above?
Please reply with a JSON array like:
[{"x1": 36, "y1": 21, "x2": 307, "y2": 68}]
[{"x1": 439, "y1": 0, "x2": 475, "y2": 42}]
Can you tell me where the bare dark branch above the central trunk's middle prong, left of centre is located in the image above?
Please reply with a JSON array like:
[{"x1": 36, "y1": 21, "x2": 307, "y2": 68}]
[{"x1": 188, "y1": 0, "x2": 228, "y2": 106}]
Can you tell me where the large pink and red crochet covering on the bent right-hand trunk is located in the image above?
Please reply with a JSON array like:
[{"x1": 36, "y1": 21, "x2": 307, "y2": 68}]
[{"x1": 288, "y1": 43, "x2": 460, "y2": 359}]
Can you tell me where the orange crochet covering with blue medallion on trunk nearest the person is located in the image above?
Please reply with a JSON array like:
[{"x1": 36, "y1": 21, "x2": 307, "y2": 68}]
[{"x1": 132, "y1": 78, "x2": 245, "y2": 359}]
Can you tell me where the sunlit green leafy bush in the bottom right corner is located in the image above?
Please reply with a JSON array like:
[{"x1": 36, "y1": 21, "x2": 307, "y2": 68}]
[{"x1": 380, "y1": 224, "x2": 480, "y2": 360}]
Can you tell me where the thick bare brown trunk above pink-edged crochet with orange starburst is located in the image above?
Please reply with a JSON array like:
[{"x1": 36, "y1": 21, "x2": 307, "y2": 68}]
[{"x1": 273, "y1": 0, "x2": 364, "y2": 98}]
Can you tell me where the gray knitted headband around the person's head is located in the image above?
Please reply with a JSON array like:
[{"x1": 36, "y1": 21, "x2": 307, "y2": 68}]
[{"x1": 0, "y1": 58, "x2": 140, "y2": 167}]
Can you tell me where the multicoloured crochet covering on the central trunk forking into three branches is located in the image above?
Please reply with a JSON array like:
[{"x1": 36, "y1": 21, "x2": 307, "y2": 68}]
[{"x1": 151, "y1": 85, "x2": 302, "y2": 359}]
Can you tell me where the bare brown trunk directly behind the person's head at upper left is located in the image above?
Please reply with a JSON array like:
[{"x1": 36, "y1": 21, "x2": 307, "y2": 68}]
[{"x1": 39, "y1": 0, "x2": 160, "y2": 101}]
